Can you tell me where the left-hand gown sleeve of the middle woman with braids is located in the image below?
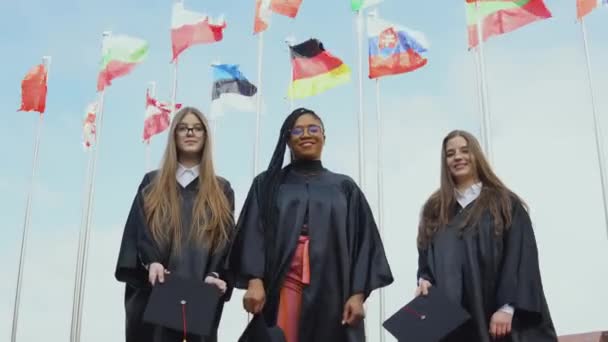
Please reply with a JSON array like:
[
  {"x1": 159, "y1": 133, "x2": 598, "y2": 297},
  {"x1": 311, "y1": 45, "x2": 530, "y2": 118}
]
[{"x1": 229, "y1": 175, "x2": 266, "y2": 289}]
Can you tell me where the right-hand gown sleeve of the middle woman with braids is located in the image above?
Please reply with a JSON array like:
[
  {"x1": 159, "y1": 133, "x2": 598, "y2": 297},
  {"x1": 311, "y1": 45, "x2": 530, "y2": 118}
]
[{"x1": 348, "y1": 180, "x2": 393, "y2": 298}]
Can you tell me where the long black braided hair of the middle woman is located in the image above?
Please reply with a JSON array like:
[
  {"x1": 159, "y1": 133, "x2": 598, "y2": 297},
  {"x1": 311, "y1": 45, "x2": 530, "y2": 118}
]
[{"x1": 260, "y1": 108, "x2": 323, "y2": 280}]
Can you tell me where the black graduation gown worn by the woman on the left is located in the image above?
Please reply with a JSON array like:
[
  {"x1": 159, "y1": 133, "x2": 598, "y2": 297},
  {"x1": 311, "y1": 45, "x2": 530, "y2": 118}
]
[{"x1": 115, "y1": 171, "x2": 234, "y2": 342}]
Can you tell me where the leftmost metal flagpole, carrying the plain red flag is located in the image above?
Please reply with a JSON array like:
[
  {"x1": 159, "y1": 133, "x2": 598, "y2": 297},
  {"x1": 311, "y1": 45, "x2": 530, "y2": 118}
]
[{"x1": 11, "y1": 56, "x2": 51, "y2": 342}]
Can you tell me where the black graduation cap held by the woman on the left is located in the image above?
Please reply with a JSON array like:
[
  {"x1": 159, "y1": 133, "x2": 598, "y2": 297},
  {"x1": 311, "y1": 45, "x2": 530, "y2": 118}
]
[{"x1": 143, "y1": 274, "x2": 221, "y2": 336}]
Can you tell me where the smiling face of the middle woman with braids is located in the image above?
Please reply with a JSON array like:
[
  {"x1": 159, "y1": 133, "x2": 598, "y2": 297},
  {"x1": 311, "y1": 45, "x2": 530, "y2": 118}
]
[{"x1": 288, "y1": 114, "x2": 325, "y2": 160}]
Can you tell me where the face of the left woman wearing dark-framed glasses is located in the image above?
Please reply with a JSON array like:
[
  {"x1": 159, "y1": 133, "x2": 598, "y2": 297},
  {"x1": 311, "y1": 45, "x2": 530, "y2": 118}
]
[{"x1": 175, "y1": 113, "x2": 206, "y2": 157}]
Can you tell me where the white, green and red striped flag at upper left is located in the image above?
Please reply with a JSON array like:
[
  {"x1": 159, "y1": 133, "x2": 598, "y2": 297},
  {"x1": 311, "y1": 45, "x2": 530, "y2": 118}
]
[{"x1": 97, "y1": 35, "x2": 148, "y2": 91}]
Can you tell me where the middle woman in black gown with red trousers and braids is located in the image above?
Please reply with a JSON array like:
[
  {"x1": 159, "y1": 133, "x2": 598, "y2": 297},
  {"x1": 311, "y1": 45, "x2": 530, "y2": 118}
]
[{"x1": 230, "y1": 108, "x2": 393, "y2": 342}]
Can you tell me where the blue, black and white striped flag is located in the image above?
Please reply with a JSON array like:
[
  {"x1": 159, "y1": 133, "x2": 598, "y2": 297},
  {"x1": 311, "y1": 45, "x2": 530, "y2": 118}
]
[{"x1": 211, "y1": 64, "x2": 258, "y2": 118}]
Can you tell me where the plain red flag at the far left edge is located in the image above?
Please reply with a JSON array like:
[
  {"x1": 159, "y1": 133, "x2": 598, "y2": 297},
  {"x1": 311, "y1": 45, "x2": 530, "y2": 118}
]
[{"x1": 17, "y1": 64, "x2": 47, "y2": 114}]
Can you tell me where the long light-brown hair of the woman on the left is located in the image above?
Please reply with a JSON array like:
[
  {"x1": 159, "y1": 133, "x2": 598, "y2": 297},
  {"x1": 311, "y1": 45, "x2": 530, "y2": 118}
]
[{"x1": 144, "y1": 107, "x2": 233, "y2": 253}]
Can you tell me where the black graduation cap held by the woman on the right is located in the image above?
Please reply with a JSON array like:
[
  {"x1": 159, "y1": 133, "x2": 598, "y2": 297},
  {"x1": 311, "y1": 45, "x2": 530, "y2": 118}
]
[{"x1": 383, "y1": 288, "x2": 470, "y2": 342}]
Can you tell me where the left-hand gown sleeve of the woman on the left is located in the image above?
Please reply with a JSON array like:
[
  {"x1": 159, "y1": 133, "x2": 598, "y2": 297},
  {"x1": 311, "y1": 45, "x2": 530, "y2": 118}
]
[{"x1": 114, "y1": 173, "x2": 152, "y2": 287}]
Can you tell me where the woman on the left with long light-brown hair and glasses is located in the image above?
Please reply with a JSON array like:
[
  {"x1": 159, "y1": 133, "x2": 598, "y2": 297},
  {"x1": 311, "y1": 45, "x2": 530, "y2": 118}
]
[{"x1": 115, "y1": 107, "x2": 234, "y2": 342}]
